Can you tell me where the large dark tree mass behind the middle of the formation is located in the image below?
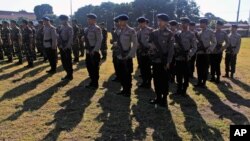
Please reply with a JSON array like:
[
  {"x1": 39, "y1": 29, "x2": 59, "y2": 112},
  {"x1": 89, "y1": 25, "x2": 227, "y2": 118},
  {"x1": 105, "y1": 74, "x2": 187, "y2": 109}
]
[{"x1": 74, "y1": 0, "x2": 199, "y2": 30}]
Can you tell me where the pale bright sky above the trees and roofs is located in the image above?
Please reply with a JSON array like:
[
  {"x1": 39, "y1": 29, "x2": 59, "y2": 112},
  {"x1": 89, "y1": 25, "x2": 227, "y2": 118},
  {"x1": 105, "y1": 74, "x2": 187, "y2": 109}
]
[{"x1": 0, "y1": 0, "x2": 250, "y2": 21}]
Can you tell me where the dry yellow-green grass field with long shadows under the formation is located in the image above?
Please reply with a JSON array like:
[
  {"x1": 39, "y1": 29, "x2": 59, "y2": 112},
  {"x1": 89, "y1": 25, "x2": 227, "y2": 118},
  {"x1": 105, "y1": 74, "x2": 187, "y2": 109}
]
[{"x1": 0, "y1": 38, "x2": 250, "y2": 141}]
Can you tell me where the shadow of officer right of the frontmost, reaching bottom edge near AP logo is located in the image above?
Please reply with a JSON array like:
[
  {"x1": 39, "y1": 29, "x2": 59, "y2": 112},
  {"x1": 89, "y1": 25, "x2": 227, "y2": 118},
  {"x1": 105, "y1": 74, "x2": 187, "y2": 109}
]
[{"x1": 170, "y1": 94, "x2": 223, "y2": 141}]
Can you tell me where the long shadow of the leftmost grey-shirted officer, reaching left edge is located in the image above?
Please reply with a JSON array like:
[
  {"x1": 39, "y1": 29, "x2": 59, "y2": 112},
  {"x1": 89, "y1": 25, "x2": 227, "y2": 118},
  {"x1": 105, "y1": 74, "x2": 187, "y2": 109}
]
[{"x1": 0, "y1": 66, "x2": 62, "y2": 102}]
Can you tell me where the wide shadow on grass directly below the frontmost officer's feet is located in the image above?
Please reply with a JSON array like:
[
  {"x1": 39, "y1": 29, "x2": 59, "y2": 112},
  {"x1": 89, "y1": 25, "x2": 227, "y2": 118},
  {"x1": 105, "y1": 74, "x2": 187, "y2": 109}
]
[{"x1": 132, "y1": 89, "x2": 182, "y2": 141}]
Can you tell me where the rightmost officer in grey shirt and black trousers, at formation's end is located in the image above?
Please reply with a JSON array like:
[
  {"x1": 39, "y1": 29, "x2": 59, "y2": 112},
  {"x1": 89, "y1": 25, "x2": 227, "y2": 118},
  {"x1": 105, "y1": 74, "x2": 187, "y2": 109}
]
[{"x1": 224, "y1": 25, "x2": 241, "y2": 78}]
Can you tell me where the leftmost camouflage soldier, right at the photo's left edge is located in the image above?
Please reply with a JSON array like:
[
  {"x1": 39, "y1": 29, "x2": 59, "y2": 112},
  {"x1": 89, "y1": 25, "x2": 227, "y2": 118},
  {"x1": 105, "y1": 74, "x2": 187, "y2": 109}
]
[{"x1": 1, "y1": 21, "x2": 13, "y2": 62}]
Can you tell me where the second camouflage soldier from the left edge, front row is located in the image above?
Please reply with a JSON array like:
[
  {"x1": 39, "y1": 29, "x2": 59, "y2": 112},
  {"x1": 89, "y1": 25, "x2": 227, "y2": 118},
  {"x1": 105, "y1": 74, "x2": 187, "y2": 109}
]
[{"x1": 11, "y1": 20, "x2": 23, "y2": 64}]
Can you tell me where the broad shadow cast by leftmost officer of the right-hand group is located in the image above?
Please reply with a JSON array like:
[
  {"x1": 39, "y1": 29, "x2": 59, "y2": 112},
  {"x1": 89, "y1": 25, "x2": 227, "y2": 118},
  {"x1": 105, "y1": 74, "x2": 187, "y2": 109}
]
[{"x1": 96, "y1": 76, "x2": 133, "y2": 141}]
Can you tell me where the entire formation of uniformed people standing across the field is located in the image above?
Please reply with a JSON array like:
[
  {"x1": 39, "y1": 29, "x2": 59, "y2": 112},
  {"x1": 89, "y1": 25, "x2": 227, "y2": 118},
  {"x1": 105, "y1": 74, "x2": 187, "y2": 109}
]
[{"x1": 0, "y1": 13, "x2": 241, "y2": 107}]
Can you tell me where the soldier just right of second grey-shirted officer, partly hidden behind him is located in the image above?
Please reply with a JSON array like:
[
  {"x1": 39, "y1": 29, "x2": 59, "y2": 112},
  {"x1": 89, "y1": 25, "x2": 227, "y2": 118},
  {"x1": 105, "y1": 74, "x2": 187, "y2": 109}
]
[{"x1": 72, "y1": 20, "x2": 80, "y2": 63}]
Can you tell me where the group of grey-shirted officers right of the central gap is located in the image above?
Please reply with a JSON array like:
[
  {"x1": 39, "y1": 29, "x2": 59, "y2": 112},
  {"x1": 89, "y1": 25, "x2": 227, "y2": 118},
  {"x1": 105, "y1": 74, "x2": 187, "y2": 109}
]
[{"x1": 111, "y1": 13, "x2": 241, "y2": 107}]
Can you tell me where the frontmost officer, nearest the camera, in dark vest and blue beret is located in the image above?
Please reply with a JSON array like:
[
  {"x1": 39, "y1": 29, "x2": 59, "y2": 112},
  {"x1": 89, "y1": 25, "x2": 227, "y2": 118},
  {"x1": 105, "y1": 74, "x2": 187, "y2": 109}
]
[{"x1": 149, "y1": 13, "x2": 174, "y2": 107}]
